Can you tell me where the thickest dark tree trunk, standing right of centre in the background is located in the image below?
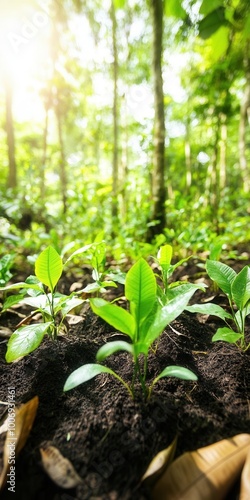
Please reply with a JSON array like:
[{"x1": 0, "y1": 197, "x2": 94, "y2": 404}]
[{"x1": 147, "y1": 0, "x2": 167, "y2": 239}]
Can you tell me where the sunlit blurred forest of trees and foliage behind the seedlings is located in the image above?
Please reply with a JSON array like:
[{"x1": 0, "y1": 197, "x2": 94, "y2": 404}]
[{"x1": 0, "y1": 0, "x2": 250, "y2": 264}]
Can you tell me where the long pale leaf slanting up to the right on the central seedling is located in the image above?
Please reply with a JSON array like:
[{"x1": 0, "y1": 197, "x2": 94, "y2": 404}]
[{"x1": 143, "y1": 288, "x2": 199, "y2": 346}]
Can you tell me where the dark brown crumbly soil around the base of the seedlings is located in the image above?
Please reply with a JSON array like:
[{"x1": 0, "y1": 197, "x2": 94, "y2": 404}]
[{"x1": 0, "y1": 261, "x2": 250, "y2": 500}]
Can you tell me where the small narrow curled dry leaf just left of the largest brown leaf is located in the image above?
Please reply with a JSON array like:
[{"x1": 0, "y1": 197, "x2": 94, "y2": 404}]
[{"x1": 141, "y1": 436, "x2": 177, "y2": 486}]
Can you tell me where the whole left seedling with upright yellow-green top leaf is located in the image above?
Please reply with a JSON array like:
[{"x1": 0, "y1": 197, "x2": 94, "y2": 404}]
[{"x1": 1, "y1": 246, "x2": 84, "y2": 363}]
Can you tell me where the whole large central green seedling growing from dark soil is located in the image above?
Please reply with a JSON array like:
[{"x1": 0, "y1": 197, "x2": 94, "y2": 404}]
[{"x1": 64, "y1": 258, "x2": 204, "y2": 398}]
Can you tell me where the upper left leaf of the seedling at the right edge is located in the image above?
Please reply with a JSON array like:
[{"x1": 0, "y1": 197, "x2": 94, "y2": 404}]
[{"x1": 206, "y1": 259, "x2": 236, "y2": 298}]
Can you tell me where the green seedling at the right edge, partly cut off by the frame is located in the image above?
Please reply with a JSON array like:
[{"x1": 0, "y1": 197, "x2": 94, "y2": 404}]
[{"x1": 186, "y1": 260, "x2": 250, "y2": 351}]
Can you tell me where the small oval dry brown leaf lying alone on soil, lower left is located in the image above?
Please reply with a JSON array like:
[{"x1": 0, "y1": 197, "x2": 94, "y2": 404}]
[{"x1": 40, "y1": 446, "x2": 82, "y2": 489}]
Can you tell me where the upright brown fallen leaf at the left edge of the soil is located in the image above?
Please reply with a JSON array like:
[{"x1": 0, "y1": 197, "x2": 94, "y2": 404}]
[{"x1": 0, "y1": 396, "x2": 39, "y2": 490}]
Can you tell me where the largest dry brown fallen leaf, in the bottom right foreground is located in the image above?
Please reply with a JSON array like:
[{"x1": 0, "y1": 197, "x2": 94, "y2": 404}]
[{"x1": 152, "y1": 434, "x2": 250, "y2": 500}]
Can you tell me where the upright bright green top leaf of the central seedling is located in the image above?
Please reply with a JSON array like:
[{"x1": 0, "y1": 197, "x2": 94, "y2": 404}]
[{"x1": 125, "y1": 258, "x2": 156, "y2": 330}]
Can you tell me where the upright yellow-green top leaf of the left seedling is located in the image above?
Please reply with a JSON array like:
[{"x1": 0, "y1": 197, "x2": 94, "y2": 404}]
[{"x1": 35, "y1": 246, "x2": 63, "y2": 292}]
